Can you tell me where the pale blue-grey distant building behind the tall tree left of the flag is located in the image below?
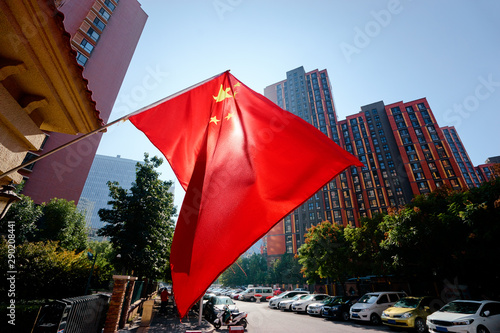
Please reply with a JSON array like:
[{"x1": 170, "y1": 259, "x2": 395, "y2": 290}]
[{"x1": 78, "y1": 155, "x2": 141, "y2": 238}]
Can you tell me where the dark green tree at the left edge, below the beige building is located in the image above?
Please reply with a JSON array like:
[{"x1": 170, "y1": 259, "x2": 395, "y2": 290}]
[{"x1": 0, "y1": 194, "x2": 43, "y2": 244}]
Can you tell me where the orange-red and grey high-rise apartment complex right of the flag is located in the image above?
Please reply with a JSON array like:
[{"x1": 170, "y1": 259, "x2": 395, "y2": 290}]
[{"x1": 264, "y1": 67, "x2": 489, "y2": 260}]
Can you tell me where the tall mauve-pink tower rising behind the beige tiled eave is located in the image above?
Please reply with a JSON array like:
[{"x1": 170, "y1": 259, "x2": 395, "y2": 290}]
[{"x1": 22, "y1": 0, "x2": 147, "y2": 203}]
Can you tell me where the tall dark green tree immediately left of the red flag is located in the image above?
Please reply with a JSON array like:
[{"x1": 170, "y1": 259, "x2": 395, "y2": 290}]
[{"x1": 98, "y1": 154, "x2": 176, "y2": 279}]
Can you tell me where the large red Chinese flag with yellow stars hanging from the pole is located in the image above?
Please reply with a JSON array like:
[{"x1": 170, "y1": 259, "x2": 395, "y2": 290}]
[{"x1": 129, "y1": 72, "x2": 362, "y2": 317}]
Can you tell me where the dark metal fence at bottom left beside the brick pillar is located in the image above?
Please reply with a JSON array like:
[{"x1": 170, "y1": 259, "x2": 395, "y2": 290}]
[{"x1": 33, "y1": 294, "x2": 110, "y2": 333}]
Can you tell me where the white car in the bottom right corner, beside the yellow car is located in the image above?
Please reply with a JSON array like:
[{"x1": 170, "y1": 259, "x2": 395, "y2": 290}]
[{"x1": 427, "y1": 300, "x2": 500, "y2": 333}]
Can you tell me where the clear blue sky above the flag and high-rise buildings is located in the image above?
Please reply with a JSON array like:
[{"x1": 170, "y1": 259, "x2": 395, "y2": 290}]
[{"x1": 98, "y1": 0, "x2": 500, "y2": 207}]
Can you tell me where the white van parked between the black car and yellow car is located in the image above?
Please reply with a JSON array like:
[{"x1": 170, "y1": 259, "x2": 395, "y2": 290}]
[{"x1": 349, "y1": 291, "x2": 406, "y2": 325}]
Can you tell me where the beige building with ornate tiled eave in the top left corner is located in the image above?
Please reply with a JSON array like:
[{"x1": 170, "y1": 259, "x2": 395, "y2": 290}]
[{"x1": 0, "y1": 0, "x2": 102, "y2": 213}]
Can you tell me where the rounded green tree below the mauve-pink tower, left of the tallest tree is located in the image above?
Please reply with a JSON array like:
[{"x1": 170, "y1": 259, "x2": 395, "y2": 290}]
[{"x1": 36, "y1": 198, "x2": 87, "y2": 252}]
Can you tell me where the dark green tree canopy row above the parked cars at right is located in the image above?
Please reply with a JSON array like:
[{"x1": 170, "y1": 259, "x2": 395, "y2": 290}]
[{"x1": 298, "y1": 178, "x2": 500, "y2": 295}]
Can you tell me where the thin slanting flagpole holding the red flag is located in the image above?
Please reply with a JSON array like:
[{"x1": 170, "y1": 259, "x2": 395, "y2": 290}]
[{"x1": 0, "y1": 70, "x2": 229, "y2": 179}]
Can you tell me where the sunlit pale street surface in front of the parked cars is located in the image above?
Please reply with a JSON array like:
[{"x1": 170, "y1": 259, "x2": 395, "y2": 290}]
[{"x1": 218, "y1": 301, "x2": 406, "y2": 333}]
